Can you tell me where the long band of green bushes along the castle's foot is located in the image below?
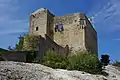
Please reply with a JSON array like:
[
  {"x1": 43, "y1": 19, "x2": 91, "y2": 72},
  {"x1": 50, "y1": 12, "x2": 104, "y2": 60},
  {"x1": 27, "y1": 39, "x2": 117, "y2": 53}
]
[{"x1": 43, "y1": 51, "x2": 102, "y2": 73}]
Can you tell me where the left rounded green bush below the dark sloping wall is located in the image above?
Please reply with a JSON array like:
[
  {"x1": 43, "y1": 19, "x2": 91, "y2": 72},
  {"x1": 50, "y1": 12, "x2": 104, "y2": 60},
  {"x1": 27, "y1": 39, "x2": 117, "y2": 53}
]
[{"x1": 43, "y1": 50, "x2": 68, "y2": 69}]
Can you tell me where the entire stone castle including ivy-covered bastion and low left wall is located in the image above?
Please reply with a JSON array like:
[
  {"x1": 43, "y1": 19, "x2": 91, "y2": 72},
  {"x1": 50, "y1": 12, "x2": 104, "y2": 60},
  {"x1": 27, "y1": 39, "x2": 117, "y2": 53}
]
[{"x1": 0, "y1": 8, "x2": 98, "y2": 62}]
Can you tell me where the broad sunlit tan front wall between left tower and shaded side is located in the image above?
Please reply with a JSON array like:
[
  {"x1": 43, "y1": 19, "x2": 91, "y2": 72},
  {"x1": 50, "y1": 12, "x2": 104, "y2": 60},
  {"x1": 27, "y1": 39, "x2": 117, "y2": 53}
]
[{"x1": 54, "y1": 13, "x2": 84, "y2": 51}]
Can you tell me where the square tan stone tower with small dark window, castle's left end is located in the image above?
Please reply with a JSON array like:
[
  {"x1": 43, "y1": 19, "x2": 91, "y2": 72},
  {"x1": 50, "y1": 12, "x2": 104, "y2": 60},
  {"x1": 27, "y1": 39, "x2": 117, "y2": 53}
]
[{"x1": 29, "y1": 8, "x2": 54, "y2": 39}]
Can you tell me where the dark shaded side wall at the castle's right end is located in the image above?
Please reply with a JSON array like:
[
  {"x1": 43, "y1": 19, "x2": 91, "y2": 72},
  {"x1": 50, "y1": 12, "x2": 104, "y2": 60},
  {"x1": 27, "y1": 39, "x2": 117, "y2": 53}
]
[{"x1": 85, "y1": 18, "x2": 98, "y2": 54}]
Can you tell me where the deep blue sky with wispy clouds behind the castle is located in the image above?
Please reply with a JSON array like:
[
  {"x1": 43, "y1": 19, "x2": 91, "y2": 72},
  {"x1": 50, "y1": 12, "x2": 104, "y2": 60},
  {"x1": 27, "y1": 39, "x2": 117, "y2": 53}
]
[{"x1": 0, "y1": 0, "x2": 120, "y2": 61}]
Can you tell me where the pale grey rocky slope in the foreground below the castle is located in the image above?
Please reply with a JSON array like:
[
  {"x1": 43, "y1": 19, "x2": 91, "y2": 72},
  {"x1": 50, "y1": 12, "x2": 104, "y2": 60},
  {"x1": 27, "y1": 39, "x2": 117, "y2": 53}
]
[{"x1": 0, "y1": 61, "x2": 120, "y2": 80}]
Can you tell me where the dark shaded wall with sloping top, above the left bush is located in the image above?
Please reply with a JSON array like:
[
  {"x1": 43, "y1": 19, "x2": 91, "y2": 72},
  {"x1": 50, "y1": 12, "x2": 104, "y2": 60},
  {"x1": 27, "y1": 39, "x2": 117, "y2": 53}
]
[{"x1": 37, "y1": 35, "x2": 69, "y2": 58}]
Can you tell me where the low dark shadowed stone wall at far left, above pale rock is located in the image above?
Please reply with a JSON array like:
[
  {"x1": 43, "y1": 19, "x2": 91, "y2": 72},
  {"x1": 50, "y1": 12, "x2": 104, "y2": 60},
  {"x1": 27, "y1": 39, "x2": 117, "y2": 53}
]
[{"x1": 0, "y1": 51, "x2": 37, "y2": 62}]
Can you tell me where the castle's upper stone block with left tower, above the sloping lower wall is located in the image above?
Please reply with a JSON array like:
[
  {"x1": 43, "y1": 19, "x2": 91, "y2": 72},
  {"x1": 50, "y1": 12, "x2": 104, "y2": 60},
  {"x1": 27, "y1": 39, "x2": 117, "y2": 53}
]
[{"x1": 29, "y1": 8, "x2": 98, "y2": 53}]
